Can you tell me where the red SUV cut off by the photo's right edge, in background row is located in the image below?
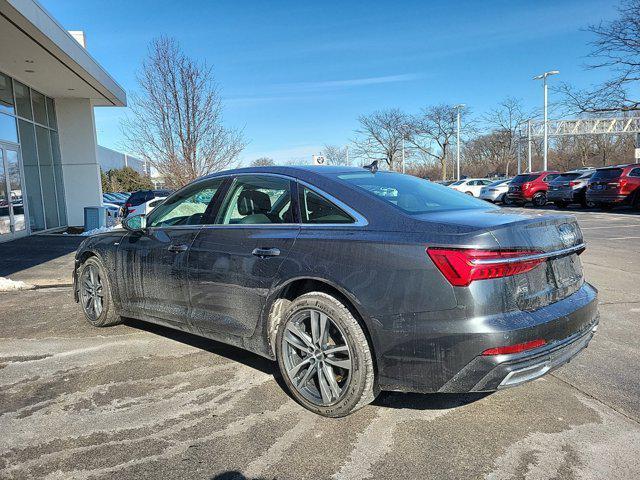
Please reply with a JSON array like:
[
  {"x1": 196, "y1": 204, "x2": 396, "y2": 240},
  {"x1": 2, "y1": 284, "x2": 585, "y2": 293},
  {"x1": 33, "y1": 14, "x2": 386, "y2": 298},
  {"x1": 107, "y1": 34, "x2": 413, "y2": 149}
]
[{"x1": 587, "y1": 163, "x2": 640, "y2": 209}]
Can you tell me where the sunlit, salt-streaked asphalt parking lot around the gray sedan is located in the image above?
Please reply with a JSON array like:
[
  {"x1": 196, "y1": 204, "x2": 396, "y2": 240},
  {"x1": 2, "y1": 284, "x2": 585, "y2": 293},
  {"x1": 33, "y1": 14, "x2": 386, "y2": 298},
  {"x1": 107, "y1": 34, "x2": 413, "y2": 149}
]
[{"x1": 0, "y1": 210, "x2": 640, "y2": 479}]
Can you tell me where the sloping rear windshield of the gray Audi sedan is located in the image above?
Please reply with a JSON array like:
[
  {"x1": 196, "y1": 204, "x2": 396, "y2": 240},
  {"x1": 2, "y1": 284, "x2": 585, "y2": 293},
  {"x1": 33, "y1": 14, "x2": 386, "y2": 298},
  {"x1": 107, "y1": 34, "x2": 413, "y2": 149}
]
[{"x1": 336, "y1": 172, "x2": 490, "y2": 215}]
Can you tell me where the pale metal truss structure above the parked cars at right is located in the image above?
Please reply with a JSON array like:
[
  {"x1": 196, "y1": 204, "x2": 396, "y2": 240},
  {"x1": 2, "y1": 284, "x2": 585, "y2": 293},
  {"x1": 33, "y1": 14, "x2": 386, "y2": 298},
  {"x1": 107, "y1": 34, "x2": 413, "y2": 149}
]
[{"x1": 518, "y1": 116, "x2": 640, "y2": 173}]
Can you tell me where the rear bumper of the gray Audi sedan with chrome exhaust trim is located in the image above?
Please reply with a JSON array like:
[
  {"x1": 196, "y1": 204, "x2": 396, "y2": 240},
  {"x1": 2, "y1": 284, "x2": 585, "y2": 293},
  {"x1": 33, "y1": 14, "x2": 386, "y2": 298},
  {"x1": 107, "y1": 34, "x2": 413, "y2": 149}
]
[{"x1": 376, "y1": 283, "x2": 598, "y2": 393}]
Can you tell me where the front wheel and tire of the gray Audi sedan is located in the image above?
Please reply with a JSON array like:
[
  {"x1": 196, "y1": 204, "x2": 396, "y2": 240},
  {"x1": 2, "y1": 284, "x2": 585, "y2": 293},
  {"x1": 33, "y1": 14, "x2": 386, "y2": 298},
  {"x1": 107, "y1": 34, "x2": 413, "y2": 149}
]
[{"x1": 78, "y1": 257, "x2": 122, "y2": 327}]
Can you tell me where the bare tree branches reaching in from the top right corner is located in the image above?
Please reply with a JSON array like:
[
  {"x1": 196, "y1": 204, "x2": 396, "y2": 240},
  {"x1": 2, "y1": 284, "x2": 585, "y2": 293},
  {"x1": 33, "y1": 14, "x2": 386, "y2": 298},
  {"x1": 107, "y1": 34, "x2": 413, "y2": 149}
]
[{"x1": 559, "y1": 0, "x2": 640, "y2": 113}]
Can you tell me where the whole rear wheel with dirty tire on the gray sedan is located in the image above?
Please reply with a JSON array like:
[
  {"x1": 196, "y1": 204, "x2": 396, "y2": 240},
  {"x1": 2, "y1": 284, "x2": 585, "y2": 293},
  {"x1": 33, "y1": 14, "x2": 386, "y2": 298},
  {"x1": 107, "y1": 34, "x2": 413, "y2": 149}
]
[{"x1": 276, "y1": 292, "x2": 377, "y2": 417}]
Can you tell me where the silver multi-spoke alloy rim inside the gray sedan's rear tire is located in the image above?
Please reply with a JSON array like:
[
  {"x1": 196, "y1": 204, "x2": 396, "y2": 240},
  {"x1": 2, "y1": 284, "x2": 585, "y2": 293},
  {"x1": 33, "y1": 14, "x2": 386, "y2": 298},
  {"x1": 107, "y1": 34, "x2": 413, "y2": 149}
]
[{"x1": 281, "y1": 309, "x2": 352, "y2": 406}]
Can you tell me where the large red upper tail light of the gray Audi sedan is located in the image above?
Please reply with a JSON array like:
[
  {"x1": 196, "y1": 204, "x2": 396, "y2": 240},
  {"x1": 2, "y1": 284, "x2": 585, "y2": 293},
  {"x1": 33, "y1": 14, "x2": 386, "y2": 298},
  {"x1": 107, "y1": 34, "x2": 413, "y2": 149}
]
[{"x1": 427, "y1": 248, "x2": 545, "y2": 287}]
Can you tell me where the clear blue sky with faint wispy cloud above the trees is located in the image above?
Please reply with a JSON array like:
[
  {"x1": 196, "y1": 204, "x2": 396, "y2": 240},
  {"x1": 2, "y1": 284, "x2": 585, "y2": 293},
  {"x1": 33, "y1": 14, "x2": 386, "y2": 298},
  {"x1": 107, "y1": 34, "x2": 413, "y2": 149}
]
[{"x1": 41, "y1": 0, "x2": 617, "y2": 162}]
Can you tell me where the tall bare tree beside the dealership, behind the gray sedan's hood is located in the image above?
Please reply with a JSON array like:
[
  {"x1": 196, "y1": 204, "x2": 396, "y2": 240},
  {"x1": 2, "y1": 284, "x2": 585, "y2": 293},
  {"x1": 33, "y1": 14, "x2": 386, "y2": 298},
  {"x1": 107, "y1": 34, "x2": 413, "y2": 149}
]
[{"x1": 122, "y1": 37, "x2": 245, "y2": 188}]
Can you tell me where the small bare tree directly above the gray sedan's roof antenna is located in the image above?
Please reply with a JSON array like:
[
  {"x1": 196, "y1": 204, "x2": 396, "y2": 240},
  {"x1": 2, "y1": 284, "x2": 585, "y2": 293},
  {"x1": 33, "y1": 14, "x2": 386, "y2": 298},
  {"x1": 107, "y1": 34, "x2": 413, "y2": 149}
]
[{"x1": 353, "y1": 108, "x2": 407, "y2": 170}]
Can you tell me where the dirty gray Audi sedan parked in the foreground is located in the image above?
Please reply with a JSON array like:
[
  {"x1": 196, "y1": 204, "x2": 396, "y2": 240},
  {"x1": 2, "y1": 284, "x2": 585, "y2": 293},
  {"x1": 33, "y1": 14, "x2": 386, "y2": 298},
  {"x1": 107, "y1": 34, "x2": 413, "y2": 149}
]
[{"x1": 74, "y1": 166, "x2": 598, "y2": 417}]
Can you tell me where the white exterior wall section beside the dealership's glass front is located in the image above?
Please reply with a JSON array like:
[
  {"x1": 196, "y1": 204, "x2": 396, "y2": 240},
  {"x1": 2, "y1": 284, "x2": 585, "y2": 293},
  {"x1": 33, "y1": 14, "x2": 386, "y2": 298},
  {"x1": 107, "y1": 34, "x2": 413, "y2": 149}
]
[{"x1": 55, "y1": 98, "x2": 102, "y2": 226}]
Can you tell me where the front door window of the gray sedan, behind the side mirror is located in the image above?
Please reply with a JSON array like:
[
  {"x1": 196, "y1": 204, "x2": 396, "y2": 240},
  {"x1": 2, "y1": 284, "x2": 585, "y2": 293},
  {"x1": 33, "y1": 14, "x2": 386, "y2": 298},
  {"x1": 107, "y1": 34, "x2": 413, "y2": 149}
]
[{"x1": 147, "y1": 178, "x2": 224, "y2": 227}]
